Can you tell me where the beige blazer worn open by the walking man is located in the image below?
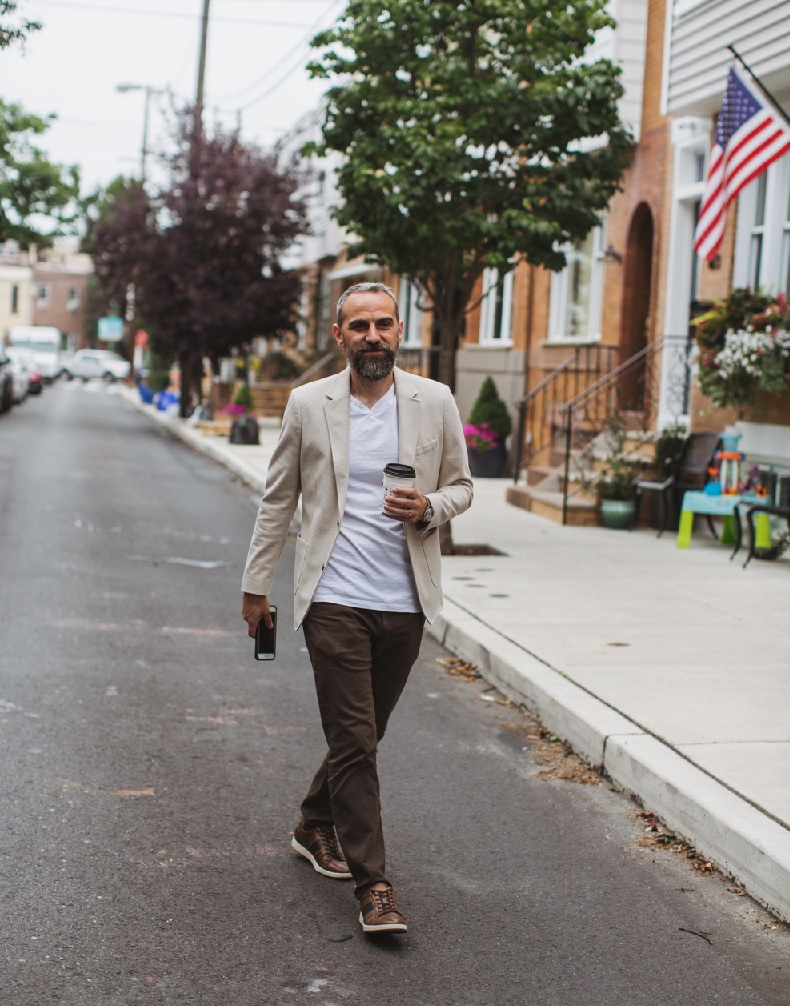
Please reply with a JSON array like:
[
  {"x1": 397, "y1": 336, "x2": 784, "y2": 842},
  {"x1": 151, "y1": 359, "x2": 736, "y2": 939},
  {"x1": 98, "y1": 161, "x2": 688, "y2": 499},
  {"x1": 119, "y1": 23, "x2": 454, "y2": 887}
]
[{"x1": 242, "y1": 367, "x2": 472, "y2": 628}]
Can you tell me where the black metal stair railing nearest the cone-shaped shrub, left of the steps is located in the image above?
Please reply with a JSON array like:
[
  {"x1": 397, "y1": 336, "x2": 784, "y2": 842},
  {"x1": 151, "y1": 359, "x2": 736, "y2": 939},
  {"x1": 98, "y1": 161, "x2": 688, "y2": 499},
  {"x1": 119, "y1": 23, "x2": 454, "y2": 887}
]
[{"x1": 513, "y1": 345, "x2": 619, "y2": 482}]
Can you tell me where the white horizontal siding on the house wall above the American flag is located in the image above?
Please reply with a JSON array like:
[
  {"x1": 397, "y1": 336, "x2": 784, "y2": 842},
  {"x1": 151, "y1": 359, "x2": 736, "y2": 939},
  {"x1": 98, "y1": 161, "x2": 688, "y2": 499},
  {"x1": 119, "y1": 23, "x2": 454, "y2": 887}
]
[{"x1": 667, "y1": 0, "x2": 790, "y2": 116}]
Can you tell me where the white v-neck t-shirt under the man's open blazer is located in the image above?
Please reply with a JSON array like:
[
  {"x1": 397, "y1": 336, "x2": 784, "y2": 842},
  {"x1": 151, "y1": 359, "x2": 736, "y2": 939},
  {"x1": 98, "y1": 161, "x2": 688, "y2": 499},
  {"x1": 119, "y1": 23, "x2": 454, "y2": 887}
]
[{"x1": 313, "y1": 386, "x2": 422, "y2": 612}]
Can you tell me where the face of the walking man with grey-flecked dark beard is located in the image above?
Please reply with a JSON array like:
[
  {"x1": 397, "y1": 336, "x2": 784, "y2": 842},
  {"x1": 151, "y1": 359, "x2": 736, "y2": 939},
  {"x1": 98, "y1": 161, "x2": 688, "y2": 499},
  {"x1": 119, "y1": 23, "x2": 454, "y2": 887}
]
[{"x1": 332, "y1": 293, "x2": 404, "y2": 381}]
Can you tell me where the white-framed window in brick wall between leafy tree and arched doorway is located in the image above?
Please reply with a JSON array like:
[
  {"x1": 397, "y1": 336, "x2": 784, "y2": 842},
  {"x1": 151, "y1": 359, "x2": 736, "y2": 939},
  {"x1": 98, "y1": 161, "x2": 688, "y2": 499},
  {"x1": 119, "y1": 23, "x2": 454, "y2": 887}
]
[{"x1": 548, "y1": 227, "x2": 604, "y2": 342}]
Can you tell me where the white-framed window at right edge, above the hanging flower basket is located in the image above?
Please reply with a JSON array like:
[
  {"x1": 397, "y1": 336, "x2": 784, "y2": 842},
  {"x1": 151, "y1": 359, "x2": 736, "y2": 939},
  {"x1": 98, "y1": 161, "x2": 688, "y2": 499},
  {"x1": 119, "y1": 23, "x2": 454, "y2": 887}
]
[{"x1": 733, "y1": 154, "x2": 790, "y2": 294}]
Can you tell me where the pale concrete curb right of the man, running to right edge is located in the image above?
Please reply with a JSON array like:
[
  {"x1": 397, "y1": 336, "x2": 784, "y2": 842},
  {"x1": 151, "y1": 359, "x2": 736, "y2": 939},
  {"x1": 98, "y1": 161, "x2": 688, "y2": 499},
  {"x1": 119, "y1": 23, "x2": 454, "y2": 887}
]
[{"x1": 428, "y1": 598, "x2": 790, "y2": 921}]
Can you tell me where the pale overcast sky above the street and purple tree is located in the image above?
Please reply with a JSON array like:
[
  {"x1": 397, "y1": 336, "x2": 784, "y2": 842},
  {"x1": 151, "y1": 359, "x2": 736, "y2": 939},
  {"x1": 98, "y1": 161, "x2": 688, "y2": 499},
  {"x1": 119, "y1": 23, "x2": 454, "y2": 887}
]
[{"x1": 0, "y1": 0, "x2": 344, "y2": 192}]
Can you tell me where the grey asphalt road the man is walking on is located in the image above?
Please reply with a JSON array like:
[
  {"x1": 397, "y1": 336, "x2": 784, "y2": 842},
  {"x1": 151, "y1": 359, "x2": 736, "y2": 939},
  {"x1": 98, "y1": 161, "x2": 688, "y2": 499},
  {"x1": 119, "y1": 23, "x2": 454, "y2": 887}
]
[{"x1": 0, "y1": 384, "x2": 790, "y2": 1006}]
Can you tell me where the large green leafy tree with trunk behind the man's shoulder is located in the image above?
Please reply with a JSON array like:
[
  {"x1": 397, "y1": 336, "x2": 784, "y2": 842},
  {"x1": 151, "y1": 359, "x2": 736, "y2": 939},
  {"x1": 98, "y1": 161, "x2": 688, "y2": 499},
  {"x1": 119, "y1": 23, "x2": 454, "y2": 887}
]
[{"x1": 310, "y1": 0, "x2": 631, "y2": 386}]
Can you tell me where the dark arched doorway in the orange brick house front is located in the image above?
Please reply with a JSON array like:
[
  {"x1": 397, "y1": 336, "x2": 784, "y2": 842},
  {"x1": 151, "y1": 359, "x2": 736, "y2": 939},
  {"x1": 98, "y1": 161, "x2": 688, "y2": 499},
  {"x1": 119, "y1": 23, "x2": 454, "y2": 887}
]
[{"x1": 620, "y1": 202, "x2": 654, "y2": 410}]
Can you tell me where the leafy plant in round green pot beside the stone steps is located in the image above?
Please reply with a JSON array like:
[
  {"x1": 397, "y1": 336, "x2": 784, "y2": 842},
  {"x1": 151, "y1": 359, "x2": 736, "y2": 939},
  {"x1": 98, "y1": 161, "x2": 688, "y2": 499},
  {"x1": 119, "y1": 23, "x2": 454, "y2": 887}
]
[{"x1": 578, "y1": 414, "x2": 645, "y2": 531}]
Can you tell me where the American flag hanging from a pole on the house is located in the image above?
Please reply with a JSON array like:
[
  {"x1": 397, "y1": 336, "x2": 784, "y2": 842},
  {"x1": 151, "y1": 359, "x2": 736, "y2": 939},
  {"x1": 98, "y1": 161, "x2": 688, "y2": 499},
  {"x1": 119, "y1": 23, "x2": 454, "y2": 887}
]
[{"x1": 694, "y1": 65, "x2": 790, "y2": 262}]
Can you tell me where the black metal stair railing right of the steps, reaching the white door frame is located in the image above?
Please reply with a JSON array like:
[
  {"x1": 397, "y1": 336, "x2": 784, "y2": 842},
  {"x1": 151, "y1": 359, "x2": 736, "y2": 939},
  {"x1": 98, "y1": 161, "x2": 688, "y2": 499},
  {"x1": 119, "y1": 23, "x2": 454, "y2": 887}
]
[{"x1": 562, "y1": 335, "x2": 693, "y2": 524}]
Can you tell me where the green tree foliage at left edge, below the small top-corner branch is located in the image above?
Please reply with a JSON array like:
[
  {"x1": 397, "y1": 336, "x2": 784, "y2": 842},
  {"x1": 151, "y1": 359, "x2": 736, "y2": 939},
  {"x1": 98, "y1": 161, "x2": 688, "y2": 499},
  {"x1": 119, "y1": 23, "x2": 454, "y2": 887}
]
[{"x1": 0, "y1": 101, "x2": 80, "y2": 246}]
